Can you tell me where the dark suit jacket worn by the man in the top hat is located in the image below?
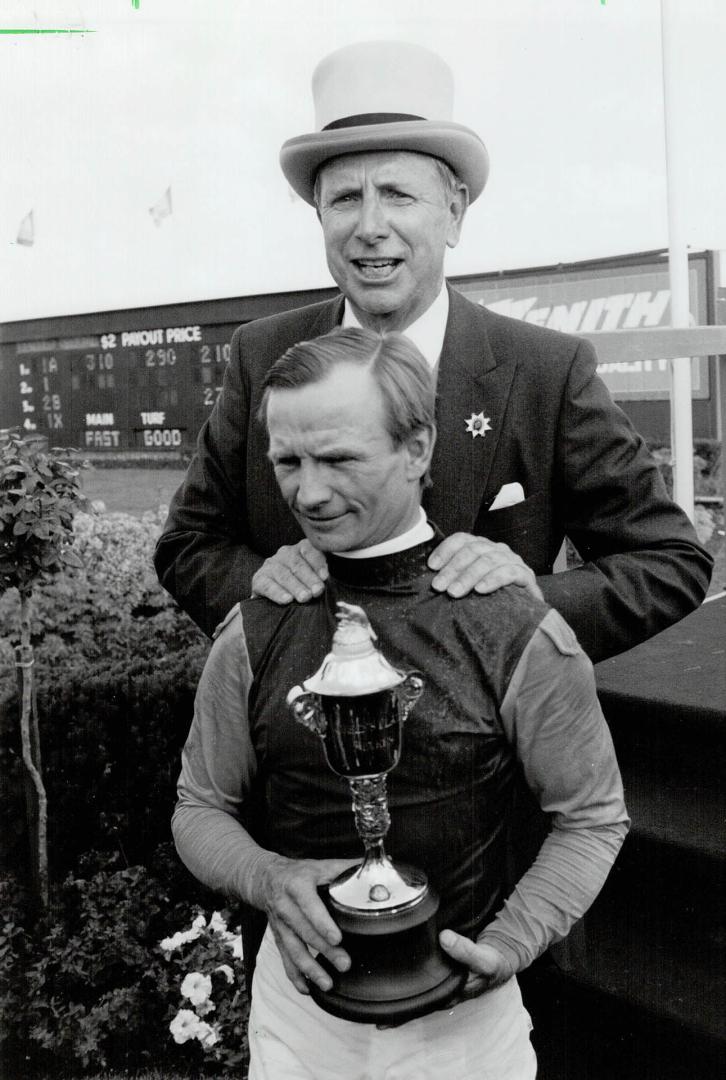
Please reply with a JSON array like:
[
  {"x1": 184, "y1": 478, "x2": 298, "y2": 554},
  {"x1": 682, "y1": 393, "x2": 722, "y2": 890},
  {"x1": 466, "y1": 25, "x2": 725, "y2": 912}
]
[{"x1": 156, "y1": 289, "x2": 712, "y2": 660}]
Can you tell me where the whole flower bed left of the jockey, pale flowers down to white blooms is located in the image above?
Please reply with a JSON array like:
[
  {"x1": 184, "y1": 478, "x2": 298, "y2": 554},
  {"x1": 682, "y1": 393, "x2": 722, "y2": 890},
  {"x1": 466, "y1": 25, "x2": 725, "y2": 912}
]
[{"x1": 0, "y1": 508, "x2": 246, "y2": 1077}]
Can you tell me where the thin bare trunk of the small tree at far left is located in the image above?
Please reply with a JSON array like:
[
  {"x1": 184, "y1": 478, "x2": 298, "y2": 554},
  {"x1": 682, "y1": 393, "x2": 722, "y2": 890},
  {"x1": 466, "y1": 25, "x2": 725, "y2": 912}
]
[{"x1": 15, "y1": 594, "x2": 49, "y2": 912}]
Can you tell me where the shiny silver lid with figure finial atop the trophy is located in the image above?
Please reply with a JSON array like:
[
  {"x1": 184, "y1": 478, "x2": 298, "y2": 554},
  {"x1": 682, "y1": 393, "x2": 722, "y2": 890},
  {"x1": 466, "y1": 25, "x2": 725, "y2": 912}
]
[{"x1": 303, "y1": 600, "x2": 405, "y2": 698}]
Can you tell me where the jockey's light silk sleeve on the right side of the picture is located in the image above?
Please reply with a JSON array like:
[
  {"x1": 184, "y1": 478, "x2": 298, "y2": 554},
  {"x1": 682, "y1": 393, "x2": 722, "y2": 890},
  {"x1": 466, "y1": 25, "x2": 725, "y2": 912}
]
[{"x1": 479, "y1": 610, "x2": 629, "y2": 971}]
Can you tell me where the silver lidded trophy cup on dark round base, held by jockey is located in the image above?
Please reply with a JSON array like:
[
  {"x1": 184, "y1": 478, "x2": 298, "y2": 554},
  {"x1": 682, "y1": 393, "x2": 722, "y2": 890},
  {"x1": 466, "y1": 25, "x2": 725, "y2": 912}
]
[{"x1": 287, "y1": 602, "x2": 466, "y2": 1024}]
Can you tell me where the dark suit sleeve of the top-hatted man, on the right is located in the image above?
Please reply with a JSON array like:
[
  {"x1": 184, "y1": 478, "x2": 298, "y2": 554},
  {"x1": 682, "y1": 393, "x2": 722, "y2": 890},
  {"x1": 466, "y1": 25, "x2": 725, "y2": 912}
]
[{"x1": 538, "y1": 342, "x2": 713, "y2": 661}]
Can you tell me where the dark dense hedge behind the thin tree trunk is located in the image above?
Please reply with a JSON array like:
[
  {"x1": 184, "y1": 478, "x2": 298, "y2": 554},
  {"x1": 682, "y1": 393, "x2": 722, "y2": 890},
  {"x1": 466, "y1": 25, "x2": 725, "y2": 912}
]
[{"x1": 0, "y1": 643, "x2": 206, "y2": 879}]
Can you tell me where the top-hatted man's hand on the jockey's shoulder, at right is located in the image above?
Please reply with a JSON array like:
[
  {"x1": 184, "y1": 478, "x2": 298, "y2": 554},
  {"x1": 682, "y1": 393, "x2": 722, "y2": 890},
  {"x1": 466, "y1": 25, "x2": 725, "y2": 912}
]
[{"x1": 429, "y1": 532, "x2": 545, "y2": 600}]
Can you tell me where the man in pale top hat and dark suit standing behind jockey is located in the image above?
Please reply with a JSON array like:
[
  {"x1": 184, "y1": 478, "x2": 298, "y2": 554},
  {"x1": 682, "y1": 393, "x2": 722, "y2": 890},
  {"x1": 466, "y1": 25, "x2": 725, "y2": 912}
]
[{"x1": 156, "y1": 42, "x2": 712, "y2": 660}]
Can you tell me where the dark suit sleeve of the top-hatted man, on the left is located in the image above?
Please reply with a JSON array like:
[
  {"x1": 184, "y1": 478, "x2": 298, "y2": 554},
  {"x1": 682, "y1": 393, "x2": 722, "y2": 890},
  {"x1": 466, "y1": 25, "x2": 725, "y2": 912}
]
[{"x1": 154, "y1": 327, "x2": 263, "y2": 636}]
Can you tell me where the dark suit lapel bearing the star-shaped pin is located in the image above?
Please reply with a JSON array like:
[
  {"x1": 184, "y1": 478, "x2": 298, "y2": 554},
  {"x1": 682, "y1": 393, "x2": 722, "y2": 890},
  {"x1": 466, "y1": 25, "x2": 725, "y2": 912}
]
[{"x1": 424, "y1": 287, "x2": 516, "y2": 536}]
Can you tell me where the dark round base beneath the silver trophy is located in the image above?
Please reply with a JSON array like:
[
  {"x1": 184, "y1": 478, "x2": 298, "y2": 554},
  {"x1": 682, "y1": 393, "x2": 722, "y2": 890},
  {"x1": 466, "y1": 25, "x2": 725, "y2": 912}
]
[{"x1": 310, "y1": 890, "x2": 468, "y2": 1025}]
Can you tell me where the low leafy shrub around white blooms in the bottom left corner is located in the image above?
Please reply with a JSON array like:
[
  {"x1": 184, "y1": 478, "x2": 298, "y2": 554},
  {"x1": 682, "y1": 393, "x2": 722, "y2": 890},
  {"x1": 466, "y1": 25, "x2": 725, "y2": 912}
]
[{"x1": 0, "y1": 848, "x2": 247, "y2": 1077}]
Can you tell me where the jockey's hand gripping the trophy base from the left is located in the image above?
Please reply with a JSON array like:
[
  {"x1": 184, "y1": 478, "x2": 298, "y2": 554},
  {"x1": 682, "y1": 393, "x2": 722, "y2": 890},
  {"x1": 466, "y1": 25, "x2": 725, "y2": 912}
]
[{"x1": 259, "y1": 855, "x2": 355, "y2": 994}]
